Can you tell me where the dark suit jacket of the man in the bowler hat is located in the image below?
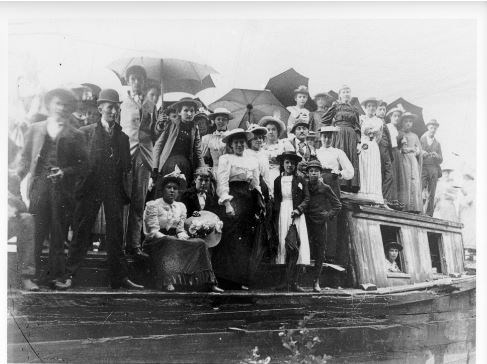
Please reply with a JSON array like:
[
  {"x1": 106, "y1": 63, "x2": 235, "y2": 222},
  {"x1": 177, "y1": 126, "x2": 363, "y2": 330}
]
[{"x1": 76, "y1": 121, "x2": 132, "y2": 203}]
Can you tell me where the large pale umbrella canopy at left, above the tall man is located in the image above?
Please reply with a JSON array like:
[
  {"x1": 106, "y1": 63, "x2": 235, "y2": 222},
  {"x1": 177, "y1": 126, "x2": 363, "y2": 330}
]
[{"x1": 108, "y1": 57, "x2": 217, "y2": 95}]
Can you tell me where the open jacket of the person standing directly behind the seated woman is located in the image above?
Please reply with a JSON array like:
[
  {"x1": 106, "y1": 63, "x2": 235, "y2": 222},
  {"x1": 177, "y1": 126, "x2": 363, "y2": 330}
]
[{"x1": 154, "y1": 120, "x2": 205, "y2": 172}]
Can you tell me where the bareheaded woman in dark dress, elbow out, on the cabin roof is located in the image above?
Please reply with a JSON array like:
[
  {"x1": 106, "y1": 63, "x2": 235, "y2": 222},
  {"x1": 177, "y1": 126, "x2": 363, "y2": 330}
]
[{"x1": 321, "y1": 86, "x2": 361, "y2": 193}]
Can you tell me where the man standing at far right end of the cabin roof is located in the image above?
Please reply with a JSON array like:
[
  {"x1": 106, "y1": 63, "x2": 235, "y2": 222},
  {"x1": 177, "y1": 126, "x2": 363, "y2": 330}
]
[{"x1": 420, "y1": 119, "x2": 443, "y2": 216}]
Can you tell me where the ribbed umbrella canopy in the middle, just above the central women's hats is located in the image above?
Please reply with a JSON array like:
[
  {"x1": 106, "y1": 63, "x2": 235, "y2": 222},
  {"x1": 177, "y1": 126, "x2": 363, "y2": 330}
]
[{"x1": 208, "y1": 88, "x2": 289, "y2": 130}]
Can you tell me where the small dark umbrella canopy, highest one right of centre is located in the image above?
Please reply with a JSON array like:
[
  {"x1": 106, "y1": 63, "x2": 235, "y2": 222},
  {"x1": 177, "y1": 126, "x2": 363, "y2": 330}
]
[{"x1": 265, "y1": 68, "x2": 316, "y2": 111}]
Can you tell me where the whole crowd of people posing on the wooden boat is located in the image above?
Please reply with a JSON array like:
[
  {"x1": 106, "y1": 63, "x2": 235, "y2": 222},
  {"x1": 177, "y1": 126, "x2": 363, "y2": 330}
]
[{"x1": 9, "y1": 66, "x2": 448, "y2": 292}]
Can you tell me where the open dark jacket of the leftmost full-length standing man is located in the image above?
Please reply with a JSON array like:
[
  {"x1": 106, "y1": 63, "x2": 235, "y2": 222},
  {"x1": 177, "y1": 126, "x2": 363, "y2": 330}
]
[{"x1": 17, "y1": 121, "x2": 88, "y2": 200}]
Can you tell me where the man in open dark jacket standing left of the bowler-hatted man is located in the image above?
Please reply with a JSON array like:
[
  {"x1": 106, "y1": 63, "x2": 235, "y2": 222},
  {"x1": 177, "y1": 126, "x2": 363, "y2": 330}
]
[{"x1": 17, "y1": 88, "x2": 87, "y2": 284}]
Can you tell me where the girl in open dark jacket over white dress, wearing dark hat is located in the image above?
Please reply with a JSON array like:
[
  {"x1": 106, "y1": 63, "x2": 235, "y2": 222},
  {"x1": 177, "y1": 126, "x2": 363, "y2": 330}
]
[{"x1": 274, "y1": 151, "x2": 310, "y2": 292}]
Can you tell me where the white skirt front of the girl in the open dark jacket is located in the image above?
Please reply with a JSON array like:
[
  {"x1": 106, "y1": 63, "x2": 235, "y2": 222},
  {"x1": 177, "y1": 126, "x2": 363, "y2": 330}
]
[{"x1": 276, "y1": 199, "x2": 310, "y2": 265}]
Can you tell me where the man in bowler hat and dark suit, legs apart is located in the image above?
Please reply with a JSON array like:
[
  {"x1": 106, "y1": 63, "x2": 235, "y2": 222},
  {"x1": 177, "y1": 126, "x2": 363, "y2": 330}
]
[{"x1": 57, "y1": 89, "x2": 144, "y2": 289}]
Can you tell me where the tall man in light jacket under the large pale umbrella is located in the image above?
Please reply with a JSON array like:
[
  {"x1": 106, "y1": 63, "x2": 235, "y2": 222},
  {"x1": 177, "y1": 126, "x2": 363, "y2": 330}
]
[{"x1": 120, "y1": 66, "x2": 156, "y2": 258}]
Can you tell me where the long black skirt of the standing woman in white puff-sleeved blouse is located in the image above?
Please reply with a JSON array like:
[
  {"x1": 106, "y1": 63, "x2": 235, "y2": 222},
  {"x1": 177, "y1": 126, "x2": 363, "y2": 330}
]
[{"x1": 212, "y1": 182, "x2": 259, "y2": 285}]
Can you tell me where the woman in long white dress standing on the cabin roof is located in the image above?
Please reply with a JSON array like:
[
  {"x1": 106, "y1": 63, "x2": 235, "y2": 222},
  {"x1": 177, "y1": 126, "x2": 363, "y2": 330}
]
[{"x1": 357, "y1": 97, "x2": 384, "y2": 204}]
